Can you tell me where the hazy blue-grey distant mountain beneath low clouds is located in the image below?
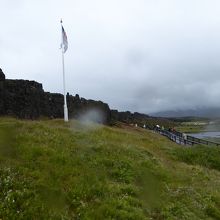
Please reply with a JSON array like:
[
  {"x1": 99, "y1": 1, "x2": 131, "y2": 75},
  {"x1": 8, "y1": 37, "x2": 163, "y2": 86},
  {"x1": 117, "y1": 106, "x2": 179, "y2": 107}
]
[{"x1": 150, "y1": 107, "x2": 220, "y2": 118}]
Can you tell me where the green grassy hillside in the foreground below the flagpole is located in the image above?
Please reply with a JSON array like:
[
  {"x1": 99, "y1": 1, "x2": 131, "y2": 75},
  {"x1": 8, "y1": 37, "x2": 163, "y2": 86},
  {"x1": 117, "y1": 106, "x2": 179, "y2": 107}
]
[{"x1": 0, "y1": 118, "x2": 220, "y2": 220}]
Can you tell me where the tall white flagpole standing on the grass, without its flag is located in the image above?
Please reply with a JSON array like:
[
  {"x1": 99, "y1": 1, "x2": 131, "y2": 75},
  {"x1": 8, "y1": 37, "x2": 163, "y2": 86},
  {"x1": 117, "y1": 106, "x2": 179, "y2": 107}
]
[{"x1": 60, "y1": 20, "x2": 69, "y2": 122}]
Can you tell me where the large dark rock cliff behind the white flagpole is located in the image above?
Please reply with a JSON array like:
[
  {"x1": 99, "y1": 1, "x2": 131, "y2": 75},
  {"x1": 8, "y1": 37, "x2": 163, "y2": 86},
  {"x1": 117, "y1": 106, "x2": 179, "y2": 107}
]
[{"x1": 0, "y1": 69, "x2": 111, "y2": 124}]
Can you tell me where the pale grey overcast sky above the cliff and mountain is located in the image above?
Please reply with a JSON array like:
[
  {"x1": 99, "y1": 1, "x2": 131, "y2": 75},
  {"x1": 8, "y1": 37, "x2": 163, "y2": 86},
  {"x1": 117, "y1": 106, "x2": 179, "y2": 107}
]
[{"x1": 0, "y1": 0, "x2": 220, "y2": 113}]
